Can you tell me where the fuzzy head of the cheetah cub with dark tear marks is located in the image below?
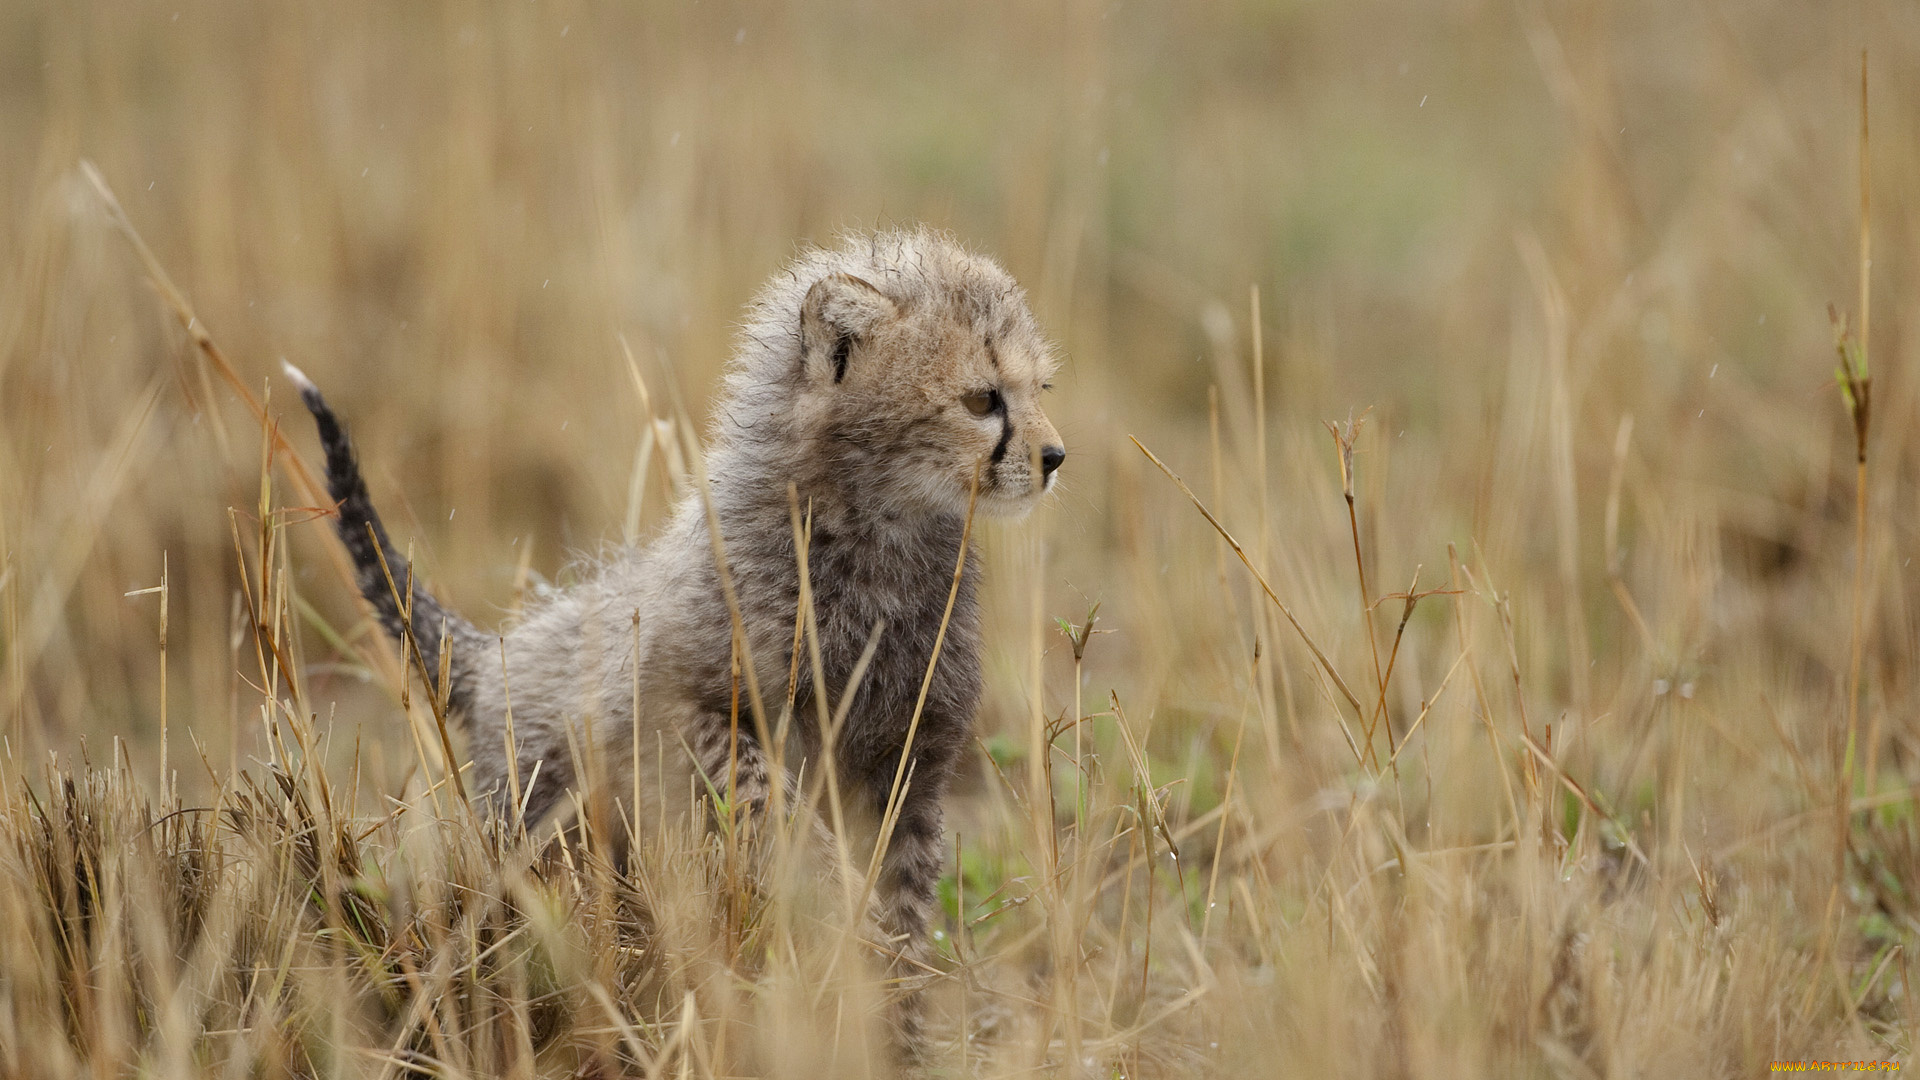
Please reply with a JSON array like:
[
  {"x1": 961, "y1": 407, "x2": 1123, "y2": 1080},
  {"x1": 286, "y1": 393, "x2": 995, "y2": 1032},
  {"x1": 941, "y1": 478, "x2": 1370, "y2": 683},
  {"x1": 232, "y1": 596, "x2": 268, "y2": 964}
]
[{"x1": 749, "y1": 231, "x2": 1066, "y2": 517}]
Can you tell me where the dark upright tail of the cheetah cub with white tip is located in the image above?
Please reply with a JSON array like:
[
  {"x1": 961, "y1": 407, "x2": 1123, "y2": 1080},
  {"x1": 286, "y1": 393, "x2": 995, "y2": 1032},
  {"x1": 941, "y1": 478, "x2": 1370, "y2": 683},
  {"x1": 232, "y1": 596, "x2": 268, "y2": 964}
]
[{"x1": 284, "y1": 363, "x2": 486, "y2": 715}]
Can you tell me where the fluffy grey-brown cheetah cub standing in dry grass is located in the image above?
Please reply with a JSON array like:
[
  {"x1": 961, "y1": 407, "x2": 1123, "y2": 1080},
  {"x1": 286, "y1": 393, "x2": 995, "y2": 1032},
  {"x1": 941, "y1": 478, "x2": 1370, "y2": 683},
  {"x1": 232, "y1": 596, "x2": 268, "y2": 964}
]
[{"x1": 288, "y1": 229, "x2": 1066, "y2": 1055}]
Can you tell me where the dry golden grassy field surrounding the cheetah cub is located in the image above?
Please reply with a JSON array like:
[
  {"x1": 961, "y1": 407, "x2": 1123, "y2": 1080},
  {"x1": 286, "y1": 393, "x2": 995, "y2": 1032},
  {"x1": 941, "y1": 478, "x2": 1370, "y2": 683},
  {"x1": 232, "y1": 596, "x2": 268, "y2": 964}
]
[{"x1": 0, "y1": 0, "x2": 1920, "y2": 1078}]
